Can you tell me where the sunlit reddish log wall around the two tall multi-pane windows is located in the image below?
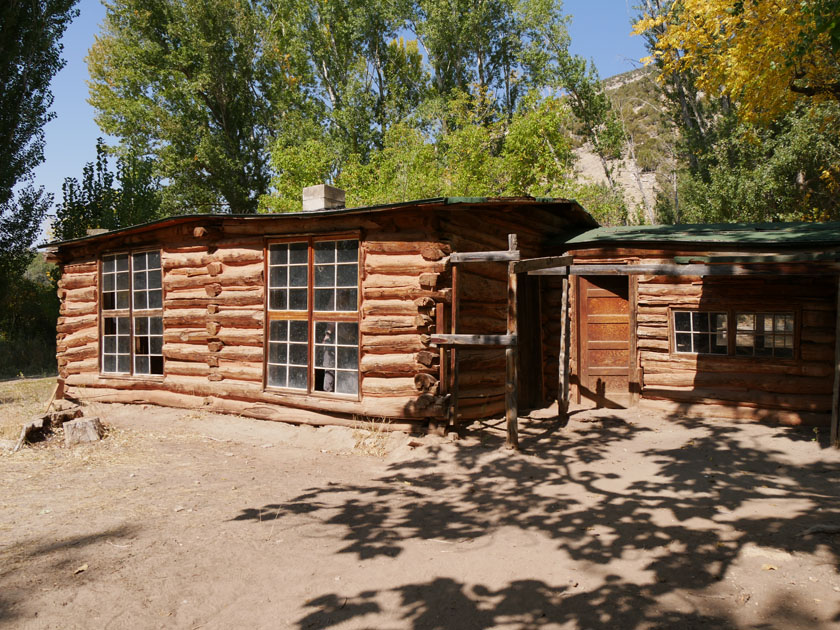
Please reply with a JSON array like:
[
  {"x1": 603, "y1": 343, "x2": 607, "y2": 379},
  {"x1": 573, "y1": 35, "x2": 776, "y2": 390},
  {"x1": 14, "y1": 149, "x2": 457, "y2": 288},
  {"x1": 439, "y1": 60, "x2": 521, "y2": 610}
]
[{"x1": 57, "y1": 211, "x2": 460, "y2": 428}]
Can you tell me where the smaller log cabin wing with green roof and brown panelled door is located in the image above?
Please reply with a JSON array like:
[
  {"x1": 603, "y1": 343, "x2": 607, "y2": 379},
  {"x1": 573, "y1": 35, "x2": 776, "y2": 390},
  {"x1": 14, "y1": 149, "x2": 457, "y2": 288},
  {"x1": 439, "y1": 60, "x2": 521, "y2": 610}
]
[{"x1": 523, "y1": 223, "x2": 840, "y2": 442}]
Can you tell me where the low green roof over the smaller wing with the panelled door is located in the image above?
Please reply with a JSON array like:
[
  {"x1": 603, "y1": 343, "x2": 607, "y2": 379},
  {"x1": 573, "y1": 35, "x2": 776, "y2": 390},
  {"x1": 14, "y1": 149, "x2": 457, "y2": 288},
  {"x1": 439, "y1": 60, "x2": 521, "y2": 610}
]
[{"x1": 557, "y1": 221, "x2": 840, "y2": 249}]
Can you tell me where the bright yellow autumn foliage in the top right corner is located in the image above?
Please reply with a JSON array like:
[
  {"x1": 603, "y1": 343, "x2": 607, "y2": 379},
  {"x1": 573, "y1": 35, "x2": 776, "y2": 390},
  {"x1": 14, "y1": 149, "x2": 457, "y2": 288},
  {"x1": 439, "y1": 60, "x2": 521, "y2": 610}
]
[{"x1": 633, "y1": 0, "x2": 840, "y2": 122}]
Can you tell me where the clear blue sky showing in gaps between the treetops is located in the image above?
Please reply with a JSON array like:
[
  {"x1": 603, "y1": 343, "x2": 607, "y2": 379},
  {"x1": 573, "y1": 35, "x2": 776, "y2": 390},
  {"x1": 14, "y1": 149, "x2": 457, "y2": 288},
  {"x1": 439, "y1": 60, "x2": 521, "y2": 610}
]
[{"x1": 35, "y1": 0, "x2": 645, "y2": 227}]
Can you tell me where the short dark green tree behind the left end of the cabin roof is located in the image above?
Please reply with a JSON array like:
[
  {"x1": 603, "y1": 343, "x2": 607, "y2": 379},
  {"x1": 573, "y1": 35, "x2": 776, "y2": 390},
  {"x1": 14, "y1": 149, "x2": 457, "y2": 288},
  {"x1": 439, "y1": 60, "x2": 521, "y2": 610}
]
[{"x1": 53, "y1": 138, "x2": 162, "y2": 240}]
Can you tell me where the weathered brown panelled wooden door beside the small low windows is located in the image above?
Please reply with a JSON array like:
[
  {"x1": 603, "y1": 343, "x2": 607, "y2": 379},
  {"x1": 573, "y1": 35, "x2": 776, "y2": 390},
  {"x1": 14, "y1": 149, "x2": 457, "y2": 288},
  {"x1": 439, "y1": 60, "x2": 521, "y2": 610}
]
[{"x1": 578, "y1": 276, "x2": 631, "y2": 407}]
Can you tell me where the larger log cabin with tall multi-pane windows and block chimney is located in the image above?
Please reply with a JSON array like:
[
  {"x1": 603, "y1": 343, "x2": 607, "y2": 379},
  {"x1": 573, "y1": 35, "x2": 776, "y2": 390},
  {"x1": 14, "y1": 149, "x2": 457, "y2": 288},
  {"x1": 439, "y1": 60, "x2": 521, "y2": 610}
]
[{"x1": 47, "y1": 186, "x2": 597, "y2": 429}]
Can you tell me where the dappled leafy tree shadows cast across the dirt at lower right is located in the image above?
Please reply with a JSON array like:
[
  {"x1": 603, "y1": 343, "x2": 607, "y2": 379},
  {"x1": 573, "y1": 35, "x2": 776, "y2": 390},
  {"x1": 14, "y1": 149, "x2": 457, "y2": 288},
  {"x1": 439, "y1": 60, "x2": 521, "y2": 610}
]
[{"x1": 235, "y1": 412, "x2": 840, "y2": 629}]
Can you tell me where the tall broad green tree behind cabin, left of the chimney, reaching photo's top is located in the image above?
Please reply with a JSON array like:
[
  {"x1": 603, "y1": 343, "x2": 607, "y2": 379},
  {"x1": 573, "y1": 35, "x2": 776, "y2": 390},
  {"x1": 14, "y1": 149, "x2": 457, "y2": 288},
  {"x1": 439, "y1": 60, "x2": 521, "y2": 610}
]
[{"x1": 88, "y1": 0, "x2": 309, "y2": 213}]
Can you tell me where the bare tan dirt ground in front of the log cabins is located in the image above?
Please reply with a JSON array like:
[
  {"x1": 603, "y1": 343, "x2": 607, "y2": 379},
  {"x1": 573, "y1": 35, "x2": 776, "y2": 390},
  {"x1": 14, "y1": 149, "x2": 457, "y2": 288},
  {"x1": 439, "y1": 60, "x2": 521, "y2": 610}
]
[{"x1": 0, "y1": 384, "x2": 840, "y2": 630}]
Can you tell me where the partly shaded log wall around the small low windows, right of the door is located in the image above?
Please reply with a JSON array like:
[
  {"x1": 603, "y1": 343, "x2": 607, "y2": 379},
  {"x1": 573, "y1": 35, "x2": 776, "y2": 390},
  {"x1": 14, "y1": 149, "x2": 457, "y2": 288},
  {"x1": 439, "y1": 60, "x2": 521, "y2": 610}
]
[{"x1": 574, "y1": 250, "x2": 836, "y2": 424}]
